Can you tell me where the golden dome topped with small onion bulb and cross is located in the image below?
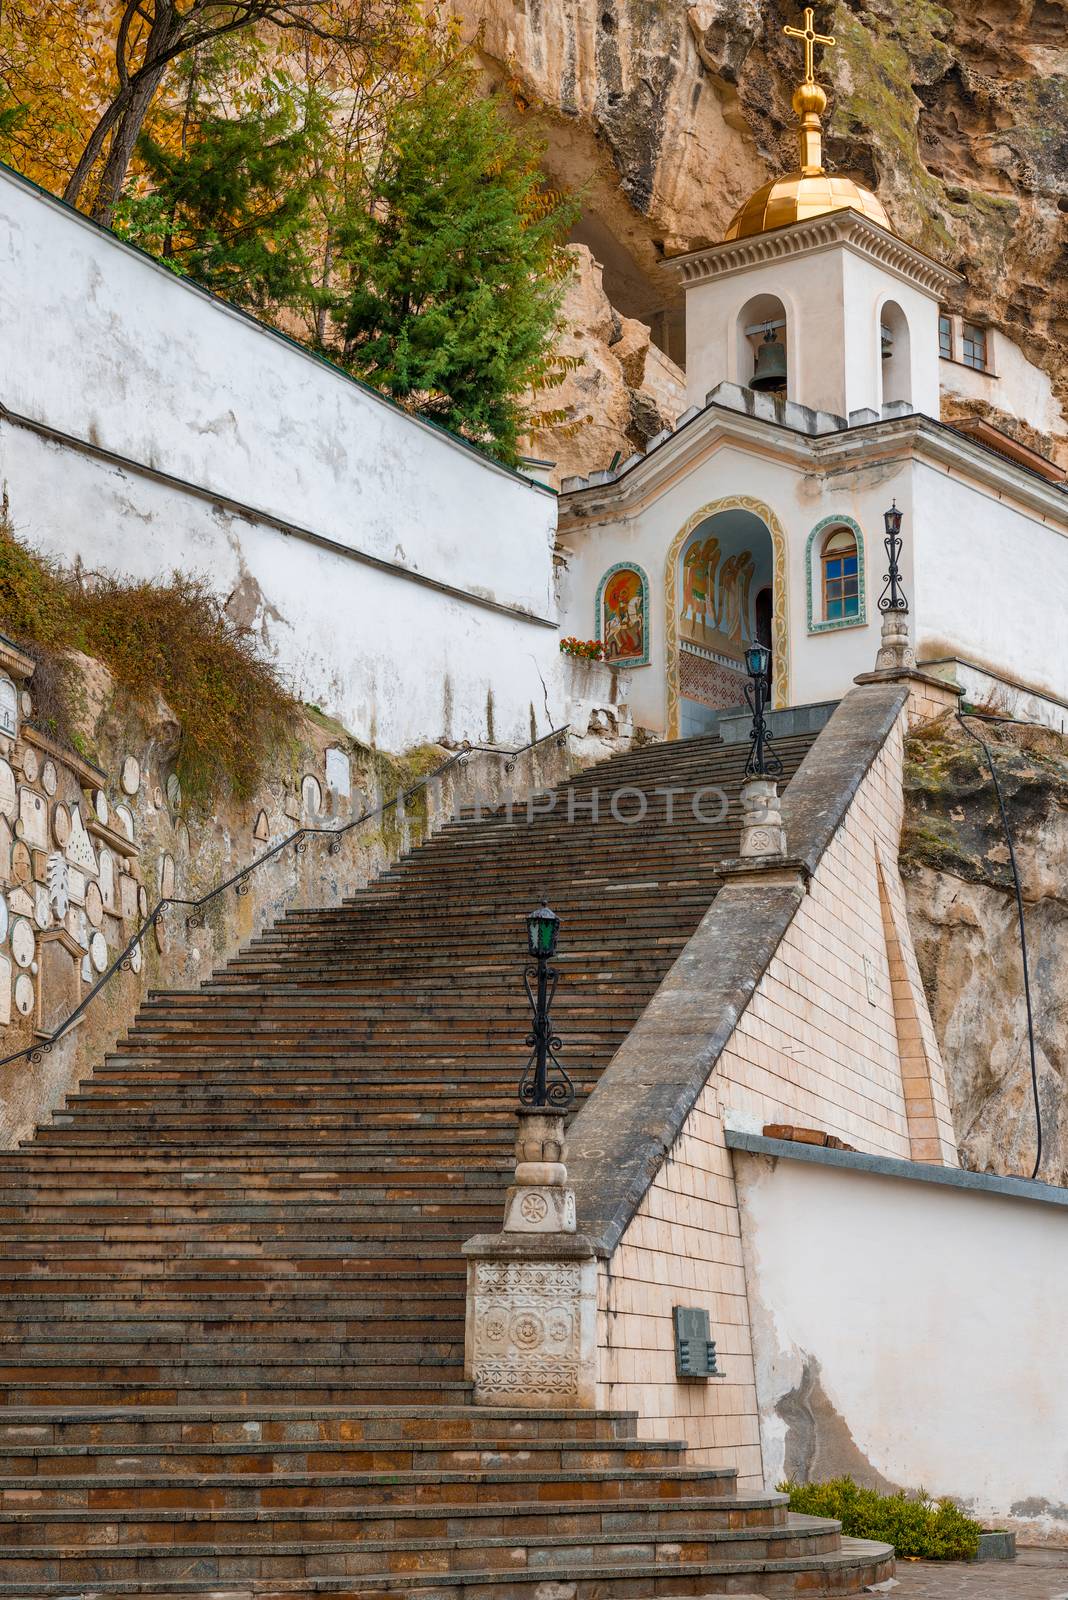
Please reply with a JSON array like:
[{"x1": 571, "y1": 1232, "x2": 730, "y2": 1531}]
[{"x1": 723, "y1": 6, "x2": 891, "y2": 242}]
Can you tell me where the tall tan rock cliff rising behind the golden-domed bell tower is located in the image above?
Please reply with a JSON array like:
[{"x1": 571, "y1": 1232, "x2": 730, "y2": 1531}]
[{"x1": 482, "y1": 0, "x2": 1068, "y2": 467}]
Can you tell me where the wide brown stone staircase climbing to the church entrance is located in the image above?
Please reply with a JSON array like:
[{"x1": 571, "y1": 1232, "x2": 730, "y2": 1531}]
[{"x1": 0, "y1": 738, "x2": 889, "y2": 1600}]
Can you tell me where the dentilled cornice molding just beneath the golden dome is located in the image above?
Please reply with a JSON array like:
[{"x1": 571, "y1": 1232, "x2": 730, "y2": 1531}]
[{"x1": 664, "y1": 210, "x2": 964, "y2": 299}]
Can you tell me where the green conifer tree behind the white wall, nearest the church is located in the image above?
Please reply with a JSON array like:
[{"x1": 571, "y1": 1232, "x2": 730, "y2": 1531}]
[{"x1": 336, "y1": 61, "x2": 576, "y2": 462}]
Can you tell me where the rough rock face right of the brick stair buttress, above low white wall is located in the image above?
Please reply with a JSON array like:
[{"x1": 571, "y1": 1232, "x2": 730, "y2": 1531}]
[{"x1": 902, "y1": 723, "x2": 1068, "y2": 1184}]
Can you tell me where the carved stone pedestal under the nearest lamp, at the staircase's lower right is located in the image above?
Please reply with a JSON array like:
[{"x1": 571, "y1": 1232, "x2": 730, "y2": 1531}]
[{"x1": 464, "y1": 1107, "x2": 596, "y2": 1408}]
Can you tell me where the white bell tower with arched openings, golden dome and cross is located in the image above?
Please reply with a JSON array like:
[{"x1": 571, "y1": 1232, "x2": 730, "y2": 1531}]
[{"x1": 667, "y1": 6, "x2": 959, "y2": 421}]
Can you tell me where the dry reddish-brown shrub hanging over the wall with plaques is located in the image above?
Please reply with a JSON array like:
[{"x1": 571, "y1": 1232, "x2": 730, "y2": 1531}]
[{"x1": 0, "y1": 520, "x2": 297, "y2": 803}]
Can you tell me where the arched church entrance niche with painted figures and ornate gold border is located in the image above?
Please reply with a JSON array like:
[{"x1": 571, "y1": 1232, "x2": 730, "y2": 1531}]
[{"x1": 664, "y1": 494, "x2": 790, "y2": 739}]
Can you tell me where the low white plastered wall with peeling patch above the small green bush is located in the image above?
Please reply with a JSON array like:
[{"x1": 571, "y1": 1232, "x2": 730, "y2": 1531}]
[{"x1": 734, "y1": 1152, "x2": 1068, "y2": 1536}]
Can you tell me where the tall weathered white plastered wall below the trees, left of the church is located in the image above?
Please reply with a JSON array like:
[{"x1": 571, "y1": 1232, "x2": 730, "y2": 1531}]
[{"x1": 0, "y1": 171, "x2": 563, "y2": 749}]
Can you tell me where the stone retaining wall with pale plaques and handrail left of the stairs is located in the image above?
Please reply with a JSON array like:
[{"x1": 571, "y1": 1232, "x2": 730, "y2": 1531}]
[{"x1": 0, "y1": 635, "x2": 568, "y2": 1147}]
